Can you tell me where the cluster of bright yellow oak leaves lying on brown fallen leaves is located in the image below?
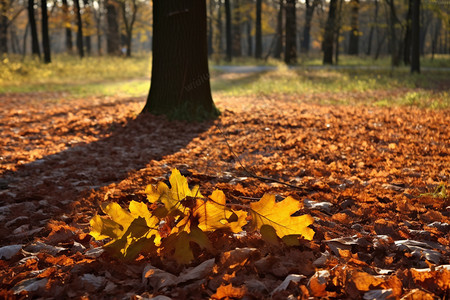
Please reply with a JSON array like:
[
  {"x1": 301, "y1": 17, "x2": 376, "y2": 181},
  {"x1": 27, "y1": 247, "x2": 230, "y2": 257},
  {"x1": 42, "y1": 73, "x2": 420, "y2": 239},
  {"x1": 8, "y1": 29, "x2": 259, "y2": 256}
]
[{"x1": 90, "y1": 169, "x2": 314, "y2": 264}]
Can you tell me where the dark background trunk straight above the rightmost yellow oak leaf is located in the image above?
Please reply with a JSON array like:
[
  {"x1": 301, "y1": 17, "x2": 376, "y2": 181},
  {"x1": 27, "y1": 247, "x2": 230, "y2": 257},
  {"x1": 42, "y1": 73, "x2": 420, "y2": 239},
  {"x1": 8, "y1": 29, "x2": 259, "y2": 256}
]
[{"x1": 284, "y1": 0, "x2": 297, "y2": 64}]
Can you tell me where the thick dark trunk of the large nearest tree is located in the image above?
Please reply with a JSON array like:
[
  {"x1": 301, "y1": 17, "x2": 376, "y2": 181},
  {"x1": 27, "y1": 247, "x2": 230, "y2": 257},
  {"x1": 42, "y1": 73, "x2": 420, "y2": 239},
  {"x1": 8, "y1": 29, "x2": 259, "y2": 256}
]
[{"x1": 143, "y1": 0, "x2": 218, "y2": 120}]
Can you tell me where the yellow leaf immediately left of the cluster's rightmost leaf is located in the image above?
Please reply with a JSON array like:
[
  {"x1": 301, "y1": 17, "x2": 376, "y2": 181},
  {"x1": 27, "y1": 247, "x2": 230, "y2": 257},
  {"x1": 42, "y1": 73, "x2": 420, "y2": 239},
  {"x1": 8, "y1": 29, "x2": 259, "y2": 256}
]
[{"x1": 193, "y1": 190, "x2": 247, "y2": 233}]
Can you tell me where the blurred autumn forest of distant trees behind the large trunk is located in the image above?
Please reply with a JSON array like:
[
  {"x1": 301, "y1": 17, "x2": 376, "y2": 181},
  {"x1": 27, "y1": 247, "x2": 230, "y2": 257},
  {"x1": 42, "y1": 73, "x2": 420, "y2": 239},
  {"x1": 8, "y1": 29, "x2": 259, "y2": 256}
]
[{"x1": 0, "y1": 0, "x2": 450, "y2": 67}]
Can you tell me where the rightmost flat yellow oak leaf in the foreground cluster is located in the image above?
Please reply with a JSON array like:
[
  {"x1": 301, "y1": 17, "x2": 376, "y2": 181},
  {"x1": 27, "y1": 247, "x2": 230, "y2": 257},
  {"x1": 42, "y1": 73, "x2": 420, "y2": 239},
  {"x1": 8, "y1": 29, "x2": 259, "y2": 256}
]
[{"x1": 250, "y1": 194, "x2": 314, "y2": 240}]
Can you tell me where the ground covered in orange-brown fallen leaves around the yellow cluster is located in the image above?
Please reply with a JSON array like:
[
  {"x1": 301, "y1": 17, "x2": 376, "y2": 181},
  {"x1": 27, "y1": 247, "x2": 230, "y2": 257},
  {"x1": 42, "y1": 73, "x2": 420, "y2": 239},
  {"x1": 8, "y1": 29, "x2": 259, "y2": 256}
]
[{"x1": 0, "y1": 93, "x2": 450, "y2": 299}]
